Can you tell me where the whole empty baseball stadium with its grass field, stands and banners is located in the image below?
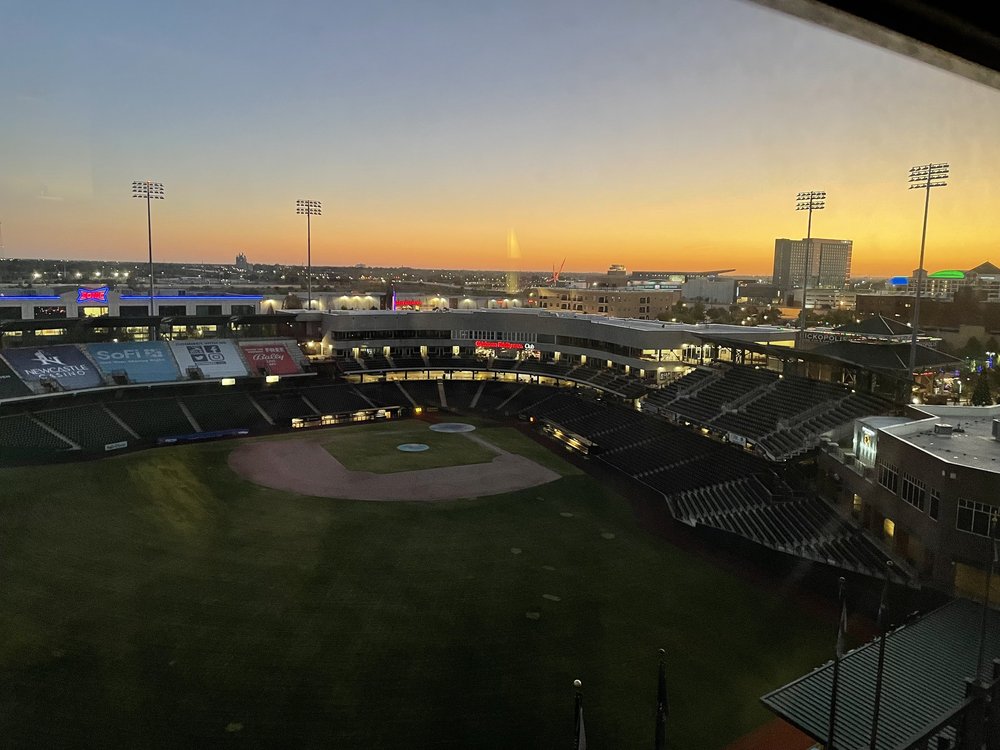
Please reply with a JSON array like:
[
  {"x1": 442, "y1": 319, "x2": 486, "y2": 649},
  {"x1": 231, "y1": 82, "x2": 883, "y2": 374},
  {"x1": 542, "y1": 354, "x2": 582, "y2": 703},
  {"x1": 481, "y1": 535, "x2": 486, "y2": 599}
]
[{"x1": 0, "y1": 310, "x2": 1000, "y2": 750}]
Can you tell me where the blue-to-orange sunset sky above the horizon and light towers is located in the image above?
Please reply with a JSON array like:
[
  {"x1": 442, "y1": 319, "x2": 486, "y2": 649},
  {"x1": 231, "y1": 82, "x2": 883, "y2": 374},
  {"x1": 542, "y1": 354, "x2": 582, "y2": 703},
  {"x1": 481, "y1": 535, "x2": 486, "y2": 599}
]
[{"x1": 0, "y1": 0, "x2": 1000, "y2": 275}]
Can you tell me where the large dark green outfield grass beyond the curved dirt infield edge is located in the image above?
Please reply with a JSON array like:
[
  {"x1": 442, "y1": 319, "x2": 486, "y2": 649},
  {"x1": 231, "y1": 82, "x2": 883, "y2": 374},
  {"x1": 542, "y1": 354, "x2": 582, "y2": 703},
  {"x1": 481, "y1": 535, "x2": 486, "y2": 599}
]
[{"x1": 0, "y1": 423, "x2": 833, "y2": 750}]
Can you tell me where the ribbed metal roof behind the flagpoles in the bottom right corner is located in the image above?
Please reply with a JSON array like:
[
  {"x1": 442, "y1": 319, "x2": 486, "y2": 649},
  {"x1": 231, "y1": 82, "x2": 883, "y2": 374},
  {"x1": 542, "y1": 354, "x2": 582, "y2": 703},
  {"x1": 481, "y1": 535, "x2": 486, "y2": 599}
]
[{"x1": 761, "y1": 599, "x2": 1000, "y2": 750}]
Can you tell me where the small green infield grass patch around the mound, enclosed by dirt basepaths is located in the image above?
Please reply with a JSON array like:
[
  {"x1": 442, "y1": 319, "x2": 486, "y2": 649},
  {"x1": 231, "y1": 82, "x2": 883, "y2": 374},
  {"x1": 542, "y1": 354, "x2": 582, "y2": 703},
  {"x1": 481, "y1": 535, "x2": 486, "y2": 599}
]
[{"x1": 323, "y1": 420, "x2": 498, "y2": 474}]
